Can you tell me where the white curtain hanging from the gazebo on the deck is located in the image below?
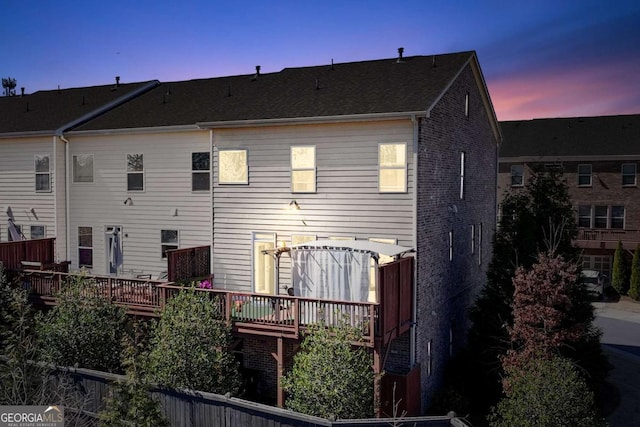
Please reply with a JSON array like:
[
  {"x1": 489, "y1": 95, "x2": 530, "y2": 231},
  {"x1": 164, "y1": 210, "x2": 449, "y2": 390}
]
[{"x1": 291, "y1": 249, "x2": 371, "y2": 302}]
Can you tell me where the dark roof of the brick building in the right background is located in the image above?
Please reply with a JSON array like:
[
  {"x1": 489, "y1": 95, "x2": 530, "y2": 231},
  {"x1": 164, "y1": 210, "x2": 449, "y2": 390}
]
[{"x1": 500, "y1": 114, "x2": 640, "y2": 157}]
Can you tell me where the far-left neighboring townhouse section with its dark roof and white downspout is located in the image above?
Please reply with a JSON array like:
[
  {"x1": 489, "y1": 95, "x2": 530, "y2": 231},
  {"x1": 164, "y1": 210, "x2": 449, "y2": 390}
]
[{"x1": 0, "y1": 81, "x2": 158, "y2": 260}]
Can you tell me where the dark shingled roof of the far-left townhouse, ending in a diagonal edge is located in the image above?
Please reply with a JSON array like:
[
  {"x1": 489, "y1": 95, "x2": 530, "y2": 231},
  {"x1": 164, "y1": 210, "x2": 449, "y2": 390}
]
[{"x1": 0, "y1": 82, "x2": 158, "y2": 134}]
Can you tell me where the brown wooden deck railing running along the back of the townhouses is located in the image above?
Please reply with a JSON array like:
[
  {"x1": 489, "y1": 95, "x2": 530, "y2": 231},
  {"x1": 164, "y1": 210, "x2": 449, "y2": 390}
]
[{"x1": 23, "y1": 270, "x2": 380, "y2": 347}]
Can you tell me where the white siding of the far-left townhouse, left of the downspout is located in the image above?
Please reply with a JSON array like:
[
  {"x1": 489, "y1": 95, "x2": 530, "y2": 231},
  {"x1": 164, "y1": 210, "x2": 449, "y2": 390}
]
[{"x1": 0, "y1": 136, "x2": 57, "y2": 249}]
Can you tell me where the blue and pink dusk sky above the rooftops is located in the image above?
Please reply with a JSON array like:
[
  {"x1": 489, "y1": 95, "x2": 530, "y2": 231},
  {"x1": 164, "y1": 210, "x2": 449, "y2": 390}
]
[{"x1": 0, "y1": 0, "x2": 640, "y2": 120}]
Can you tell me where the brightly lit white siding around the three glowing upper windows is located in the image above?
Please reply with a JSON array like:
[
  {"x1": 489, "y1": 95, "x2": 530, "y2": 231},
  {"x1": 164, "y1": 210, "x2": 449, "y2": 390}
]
[{"x1": 213, "y1": 120, "x2": 414, "y2": 290}]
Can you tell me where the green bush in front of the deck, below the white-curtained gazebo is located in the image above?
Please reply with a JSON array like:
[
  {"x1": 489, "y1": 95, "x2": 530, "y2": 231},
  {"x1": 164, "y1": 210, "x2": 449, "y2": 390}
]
[{"x1": 283, "y1": 321, "x2": 374, "y2": 419}]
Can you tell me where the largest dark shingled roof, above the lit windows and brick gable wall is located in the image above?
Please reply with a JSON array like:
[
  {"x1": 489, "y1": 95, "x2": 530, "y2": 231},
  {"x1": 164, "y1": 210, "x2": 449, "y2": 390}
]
[{"x1": 75, "y1": 51, "x2": 475, "y2": 131}]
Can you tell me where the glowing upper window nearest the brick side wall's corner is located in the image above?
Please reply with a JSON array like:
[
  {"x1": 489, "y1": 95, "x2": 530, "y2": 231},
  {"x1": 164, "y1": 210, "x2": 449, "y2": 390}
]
[{"x1": 378, "y1": 144, "x2": 407, "y2": 193}]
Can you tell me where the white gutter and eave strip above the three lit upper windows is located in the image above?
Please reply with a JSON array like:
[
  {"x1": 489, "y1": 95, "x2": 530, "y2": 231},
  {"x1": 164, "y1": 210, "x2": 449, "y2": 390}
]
[{"x1": 196, "y1": 111, "x2": 427, "y2": 129}]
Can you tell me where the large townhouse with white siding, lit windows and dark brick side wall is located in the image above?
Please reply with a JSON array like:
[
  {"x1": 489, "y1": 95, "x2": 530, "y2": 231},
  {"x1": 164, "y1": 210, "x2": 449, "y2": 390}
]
[{"x1": 0, "y1": 52, "x2": 501, "y2": 411}]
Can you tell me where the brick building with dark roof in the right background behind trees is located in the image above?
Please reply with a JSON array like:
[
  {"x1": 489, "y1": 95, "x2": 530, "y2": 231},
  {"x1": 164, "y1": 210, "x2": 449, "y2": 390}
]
[{"x1": 498, "y1": 115, "x2": 640, "y2": 277}]
